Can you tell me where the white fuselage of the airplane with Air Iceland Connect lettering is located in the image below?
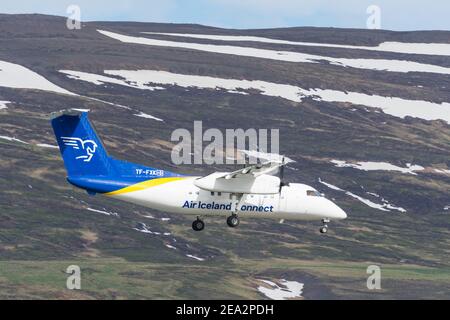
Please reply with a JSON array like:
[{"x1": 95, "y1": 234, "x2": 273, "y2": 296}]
[{"x1": 110, "y1": 177, "x2": 347, "y2": 220}]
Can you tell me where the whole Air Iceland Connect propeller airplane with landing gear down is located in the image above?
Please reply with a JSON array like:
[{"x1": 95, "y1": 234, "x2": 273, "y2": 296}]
[{"x1": 50, "y1": 110, "x2": 347, "y2": 233}]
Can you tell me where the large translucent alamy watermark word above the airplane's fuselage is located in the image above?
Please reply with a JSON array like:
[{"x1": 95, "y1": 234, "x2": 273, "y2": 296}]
[{"x1": 170, "y1": 121, "x2": 280, "y2": 165}]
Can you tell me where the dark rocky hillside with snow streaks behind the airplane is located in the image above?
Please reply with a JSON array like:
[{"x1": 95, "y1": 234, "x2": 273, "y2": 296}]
[{"x1": 0, "y1": 15, "x2": 450, "y2": 299}]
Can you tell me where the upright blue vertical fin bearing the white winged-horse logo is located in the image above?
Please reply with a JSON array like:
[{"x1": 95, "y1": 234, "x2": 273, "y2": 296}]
[{"x1": 52, "y1": 112, "x2": 114, "y2": 177}]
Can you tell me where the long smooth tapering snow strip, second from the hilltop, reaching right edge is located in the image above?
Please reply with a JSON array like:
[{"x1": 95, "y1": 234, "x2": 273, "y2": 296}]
[{"x1": 97, "y1": 30, "x2": 450, "y2": 74}]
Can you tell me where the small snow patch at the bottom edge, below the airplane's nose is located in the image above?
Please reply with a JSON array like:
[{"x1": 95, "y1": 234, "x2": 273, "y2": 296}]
[{"x1": 257, "y1": 279, "x2": 304, "y2": 300}]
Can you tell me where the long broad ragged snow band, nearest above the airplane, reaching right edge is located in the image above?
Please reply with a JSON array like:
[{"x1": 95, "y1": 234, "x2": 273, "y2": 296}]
[{"x1": 62, "y1": 70, "x2": 450, "y2": 123}]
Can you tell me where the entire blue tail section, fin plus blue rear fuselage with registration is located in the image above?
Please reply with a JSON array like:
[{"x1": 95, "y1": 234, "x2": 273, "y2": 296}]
[{"x1": 52, "y1": 112, "x2": 181, "y2": 194}]
